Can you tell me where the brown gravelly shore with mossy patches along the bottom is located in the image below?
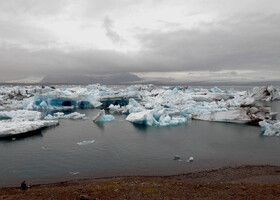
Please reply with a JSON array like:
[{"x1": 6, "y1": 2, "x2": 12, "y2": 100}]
[{"x1": 0, "y1": 165, "x2": 280, "y2": 199}]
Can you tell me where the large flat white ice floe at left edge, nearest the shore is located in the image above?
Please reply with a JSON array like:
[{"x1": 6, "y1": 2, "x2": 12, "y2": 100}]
[{"x1": 0, "y1": 120, "x2": 58, "y2": 137}]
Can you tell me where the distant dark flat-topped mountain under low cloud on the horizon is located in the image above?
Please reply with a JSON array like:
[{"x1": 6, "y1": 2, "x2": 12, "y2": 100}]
[{"x1": 40, "y1": 73, "x2": 142, "y2": 85}]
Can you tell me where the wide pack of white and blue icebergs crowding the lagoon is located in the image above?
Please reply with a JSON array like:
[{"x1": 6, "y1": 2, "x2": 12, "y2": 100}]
[{"x1": 0, "y1": 84, "x2": 280, "y2": 135}]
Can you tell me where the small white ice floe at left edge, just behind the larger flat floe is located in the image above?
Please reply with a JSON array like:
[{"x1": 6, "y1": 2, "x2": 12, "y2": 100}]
[{"x1": 0, "y1": 110, "x2": 41, "y2": 121}]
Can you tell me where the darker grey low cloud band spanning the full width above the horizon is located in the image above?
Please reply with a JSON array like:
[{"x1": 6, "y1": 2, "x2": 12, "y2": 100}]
[{"x1": 0, "y1": 15, "x2": 280, "y2": 79}]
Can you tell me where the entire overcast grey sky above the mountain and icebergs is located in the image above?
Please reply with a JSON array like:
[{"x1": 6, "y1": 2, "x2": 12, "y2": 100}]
[{"x1": 0, "y1": 0, "x2": 280, "y2": 82}]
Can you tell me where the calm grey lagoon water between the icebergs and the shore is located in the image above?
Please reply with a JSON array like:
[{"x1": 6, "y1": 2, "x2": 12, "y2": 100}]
[{"x1": 0, "y1": 102, "x2": 280, "y2": 186}]
